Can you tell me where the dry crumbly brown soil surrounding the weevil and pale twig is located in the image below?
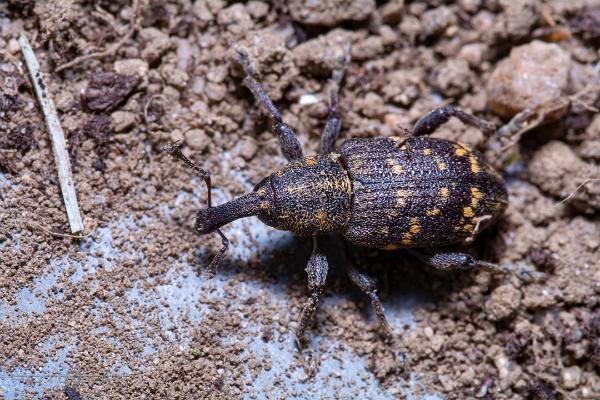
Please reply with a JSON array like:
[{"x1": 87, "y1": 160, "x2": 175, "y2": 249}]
[{"x1": 0, "y1": 0, "x2": 600, "y2": 399}]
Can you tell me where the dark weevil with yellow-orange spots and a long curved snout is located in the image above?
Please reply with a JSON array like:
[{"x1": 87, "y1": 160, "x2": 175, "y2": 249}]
[{"x1": 168, "y1": 47, "x2": 508, "y2": 342}]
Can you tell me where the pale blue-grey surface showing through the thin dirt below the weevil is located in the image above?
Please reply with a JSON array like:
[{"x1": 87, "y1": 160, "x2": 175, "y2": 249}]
[{"x1": 0, "y1": 185, "x2": 441, "y2": 400}]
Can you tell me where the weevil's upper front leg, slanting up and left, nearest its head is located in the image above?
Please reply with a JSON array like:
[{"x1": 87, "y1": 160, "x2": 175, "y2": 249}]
[{"x1": 233, "y1": 44, "x2": 303, "y2": 161}]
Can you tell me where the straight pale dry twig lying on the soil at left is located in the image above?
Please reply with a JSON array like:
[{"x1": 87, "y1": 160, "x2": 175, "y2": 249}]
[{"x1": 19, "y1": 35, "x2": 83, "y2": 234}]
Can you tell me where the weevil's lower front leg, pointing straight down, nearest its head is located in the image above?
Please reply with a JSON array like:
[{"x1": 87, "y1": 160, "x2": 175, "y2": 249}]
[{"x1": 296, "y1": 237, "x2": 329, "y2": 347}]
